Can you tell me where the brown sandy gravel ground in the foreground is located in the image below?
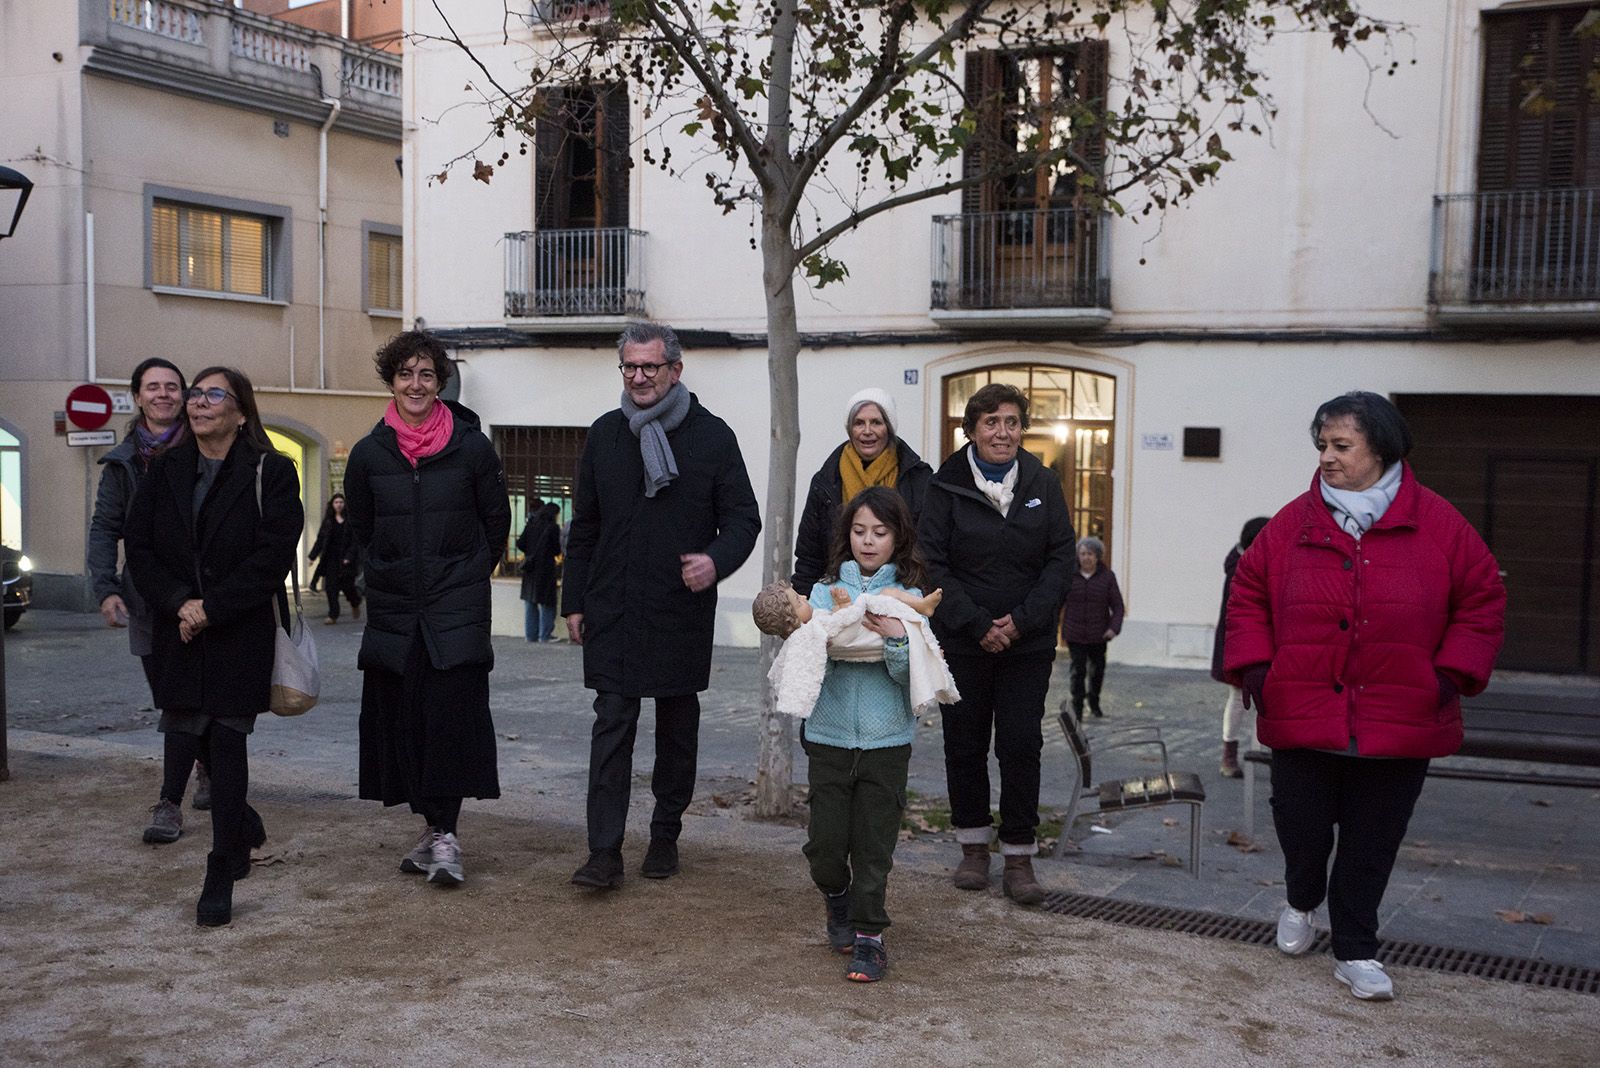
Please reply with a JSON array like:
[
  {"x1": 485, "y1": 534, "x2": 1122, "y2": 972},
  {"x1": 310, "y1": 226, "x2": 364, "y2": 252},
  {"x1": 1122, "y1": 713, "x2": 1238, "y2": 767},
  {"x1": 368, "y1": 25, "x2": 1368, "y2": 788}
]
[{"x1": 0, "y1": 732, "x2": 1600, "y2": 1068}]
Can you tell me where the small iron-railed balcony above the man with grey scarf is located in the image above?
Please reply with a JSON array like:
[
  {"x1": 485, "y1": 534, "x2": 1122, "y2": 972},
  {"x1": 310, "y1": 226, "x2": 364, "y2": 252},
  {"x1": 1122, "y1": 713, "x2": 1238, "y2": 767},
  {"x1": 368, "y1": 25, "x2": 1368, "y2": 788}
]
[{"x1": 506, "y1": 227, "x2": 646, "y2": 322}]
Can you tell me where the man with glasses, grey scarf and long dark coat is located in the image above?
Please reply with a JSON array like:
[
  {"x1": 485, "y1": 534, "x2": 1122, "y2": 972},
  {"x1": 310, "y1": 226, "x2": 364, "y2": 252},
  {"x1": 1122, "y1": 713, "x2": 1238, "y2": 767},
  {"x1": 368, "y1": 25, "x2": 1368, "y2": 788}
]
[{"x1": 562, "y1": 323, "x2": 762, "y2": 889}]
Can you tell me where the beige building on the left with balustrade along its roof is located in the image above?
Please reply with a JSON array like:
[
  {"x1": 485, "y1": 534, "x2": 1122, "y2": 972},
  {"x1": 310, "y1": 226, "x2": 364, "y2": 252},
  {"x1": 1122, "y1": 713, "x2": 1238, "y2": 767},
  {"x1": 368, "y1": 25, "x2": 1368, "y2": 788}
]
[{"x1": 0, "y1": 0, "x2": 405, "y2": 608}]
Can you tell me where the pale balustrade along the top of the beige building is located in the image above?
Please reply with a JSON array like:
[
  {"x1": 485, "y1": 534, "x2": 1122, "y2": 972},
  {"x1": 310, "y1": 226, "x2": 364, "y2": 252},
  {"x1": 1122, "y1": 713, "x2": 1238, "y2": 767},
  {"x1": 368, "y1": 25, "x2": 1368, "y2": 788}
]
[{"x1": 89, "y1": 0, "x2": 400, "y2": 137}]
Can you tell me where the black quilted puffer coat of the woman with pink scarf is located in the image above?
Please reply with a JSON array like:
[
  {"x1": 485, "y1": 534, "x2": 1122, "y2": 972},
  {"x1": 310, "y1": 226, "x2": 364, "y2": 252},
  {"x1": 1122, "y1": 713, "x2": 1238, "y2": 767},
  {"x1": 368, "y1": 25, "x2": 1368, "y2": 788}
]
[{"x1": 344, "y1": 401, "x2": 510, "y2": 675}]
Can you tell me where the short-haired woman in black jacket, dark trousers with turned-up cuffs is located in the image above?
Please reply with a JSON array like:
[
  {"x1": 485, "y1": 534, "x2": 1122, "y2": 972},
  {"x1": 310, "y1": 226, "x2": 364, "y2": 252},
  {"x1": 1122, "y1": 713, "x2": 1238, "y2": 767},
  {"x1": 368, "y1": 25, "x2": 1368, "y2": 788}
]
[{"x1": 917, "y1": 382, "x2": 1074, "y2": 905}]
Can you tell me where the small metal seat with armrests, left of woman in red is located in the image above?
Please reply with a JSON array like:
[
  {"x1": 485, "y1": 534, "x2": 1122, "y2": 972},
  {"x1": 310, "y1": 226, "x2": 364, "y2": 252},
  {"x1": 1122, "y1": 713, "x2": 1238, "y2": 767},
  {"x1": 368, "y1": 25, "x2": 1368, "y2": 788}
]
[{"x1": 1058, "y1": 702, "x2": 1205, "y2": 879}]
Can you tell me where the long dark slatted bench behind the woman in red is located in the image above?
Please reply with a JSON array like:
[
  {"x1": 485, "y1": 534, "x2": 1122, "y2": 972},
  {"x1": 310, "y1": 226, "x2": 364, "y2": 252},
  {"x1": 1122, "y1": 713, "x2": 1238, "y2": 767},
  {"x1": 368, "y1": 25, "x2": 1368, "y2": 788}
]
[{"x1": 1243, "y1": 691, "x2": 1600, "y2": 836}]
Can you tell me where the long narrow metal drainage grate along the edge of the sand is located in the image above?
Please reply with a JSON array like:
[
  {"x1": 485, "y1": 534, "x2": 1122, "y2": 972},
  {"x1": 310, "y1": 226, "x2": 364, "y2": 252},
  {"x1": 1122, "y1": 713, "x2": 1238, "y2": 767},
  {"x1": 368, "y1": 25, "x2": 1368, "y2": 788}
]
[{"x1": 1043, "y1": 892, "x2": 1600, "y2": 994}]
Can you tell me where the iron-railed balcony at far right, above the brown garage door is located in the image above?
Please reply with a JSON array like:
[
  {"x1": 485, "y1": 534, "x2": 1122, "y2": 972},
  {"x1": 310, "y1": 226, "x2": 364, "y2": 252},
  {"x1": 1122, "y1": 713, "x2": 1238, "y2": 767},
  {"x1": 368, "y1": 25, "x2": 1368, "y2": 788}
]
[{"x1": 1429, "y1": 189, "x2": 1600, "y2": 326}]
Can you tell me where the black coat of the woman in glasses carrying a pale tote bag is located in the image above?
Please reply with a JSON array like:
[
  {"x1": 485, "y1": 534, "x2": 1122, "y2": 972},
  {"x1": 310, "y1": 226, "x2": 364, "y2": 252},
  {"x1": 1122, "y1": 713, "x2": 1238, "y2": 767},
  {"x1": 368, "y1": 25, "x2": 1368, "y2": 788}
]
[{"x1": 123, "y1": 438, "x2": 306, "y2": 716}]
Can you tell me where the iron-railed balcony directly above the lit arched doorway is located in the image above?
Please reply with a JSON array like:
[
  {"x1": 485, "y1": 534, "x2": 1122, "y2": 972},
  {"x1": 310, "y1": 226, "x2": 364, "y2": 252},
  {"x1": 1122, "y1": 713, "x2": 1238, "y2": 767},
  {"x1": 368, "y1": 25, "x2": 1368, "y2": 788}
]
[{"x1": 930, "y1": 208, "x2": 1110, "y2": 329}]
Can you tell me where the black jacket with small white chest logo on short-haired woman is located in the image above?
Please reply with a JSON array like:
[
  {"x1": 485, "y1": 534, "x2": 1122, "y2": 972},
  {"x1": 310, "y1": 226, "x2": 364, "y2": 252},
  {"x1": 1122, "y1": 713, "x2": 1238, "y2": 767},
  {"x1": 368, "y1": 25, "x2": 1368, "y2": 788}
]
[{"x1": 917, "y1": 444, "x2": 1077, "y2": 656}]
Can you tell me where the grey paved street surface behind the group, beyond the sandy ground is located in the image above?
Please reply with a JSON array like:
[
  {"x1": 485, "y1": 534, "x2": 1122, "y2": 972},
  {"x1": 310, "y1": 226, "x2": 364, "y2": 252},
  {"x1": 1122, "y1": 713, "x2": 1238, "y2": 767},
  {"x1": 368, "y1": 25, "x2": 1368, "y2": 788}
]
[{"x1": 9, "y1": 611, "x2": 1600, "y2": 967}]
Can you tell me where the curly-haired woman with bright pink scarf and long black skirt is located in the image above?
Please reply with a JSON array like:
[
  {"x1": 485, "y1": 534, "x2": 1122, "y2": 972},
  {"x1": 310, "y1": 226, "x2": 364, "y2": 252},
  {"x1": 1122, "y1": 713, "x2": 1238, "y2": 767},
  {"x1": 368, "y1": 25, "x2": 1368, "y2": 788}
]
[{"x1": 345, "y1": 331, "x2": 510, "y2": 886}]
